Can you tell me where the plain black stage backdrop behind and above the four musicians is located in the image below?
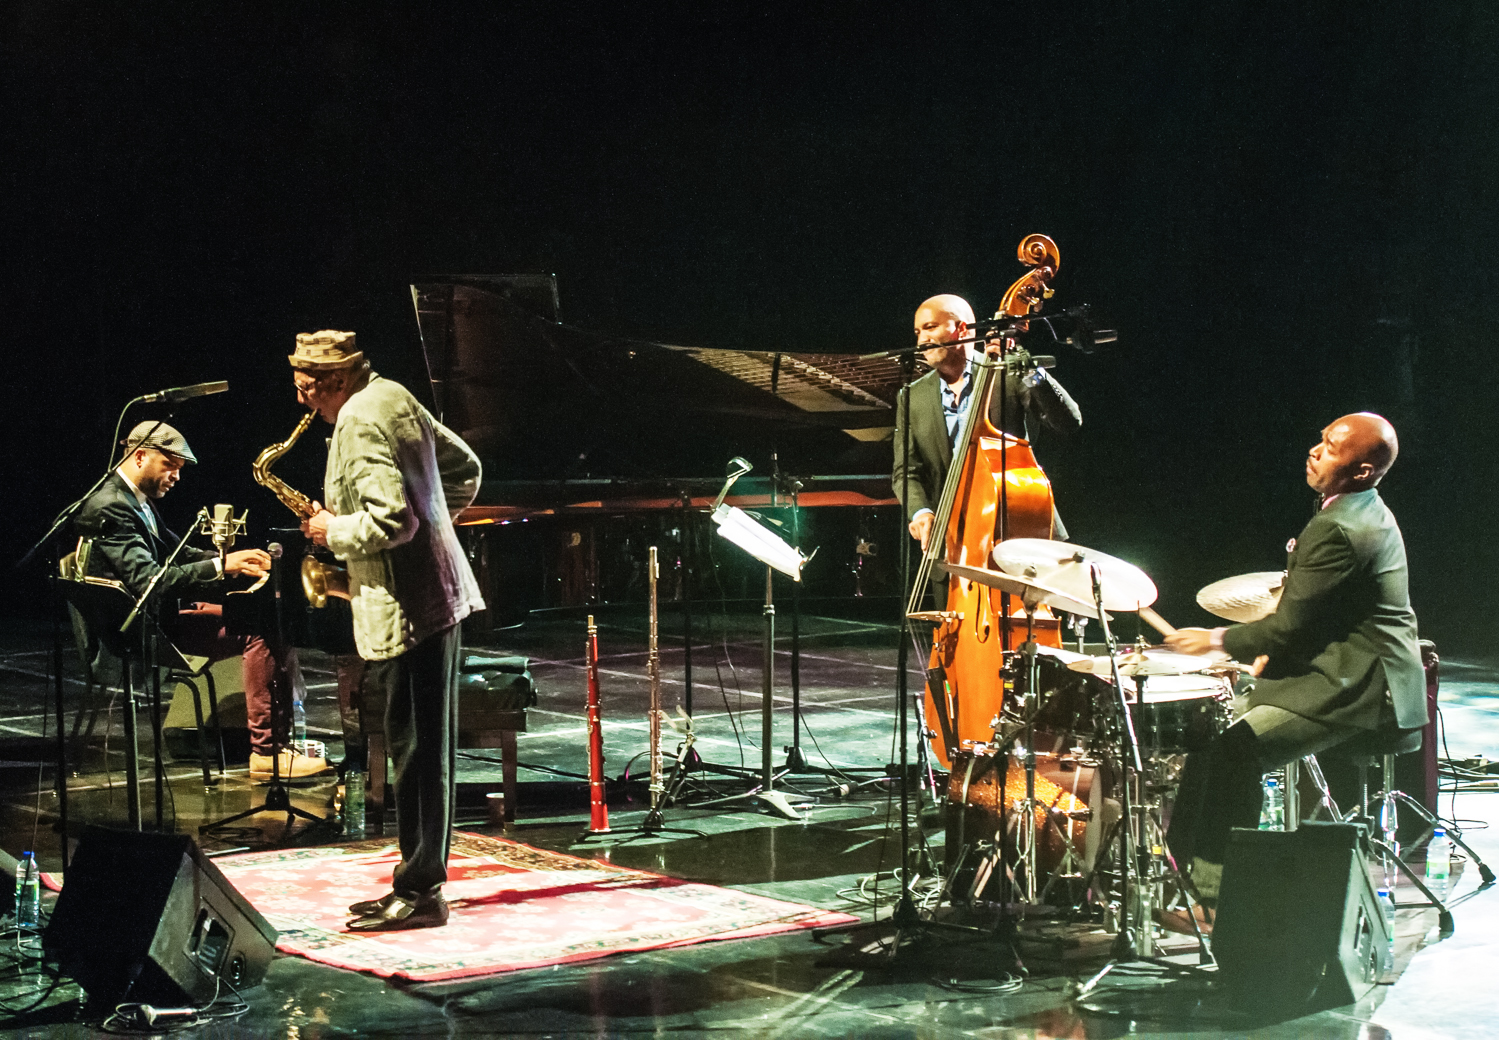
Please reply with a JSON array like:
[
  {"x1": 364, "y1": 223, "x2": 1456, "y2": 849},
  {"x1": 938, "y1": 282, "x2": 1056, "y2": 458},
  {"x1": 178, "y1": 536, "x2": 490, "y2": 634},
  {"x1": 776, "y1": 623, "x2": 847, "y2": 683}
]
[{"x1": 0, "y1": 0, "x2": 1499, "y2": 652}]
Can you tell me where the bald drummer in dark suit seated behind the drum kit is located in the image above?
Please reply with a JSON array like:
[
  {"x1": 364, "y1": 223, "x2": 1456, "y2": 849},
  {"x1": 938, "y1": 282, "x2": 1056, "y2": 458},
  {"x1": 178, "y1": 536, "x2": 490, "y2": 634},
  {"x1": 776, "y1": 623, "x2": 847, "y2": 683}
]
[{"x1": 1160, "y1": 412, "x2": 1427, "y2": 931}]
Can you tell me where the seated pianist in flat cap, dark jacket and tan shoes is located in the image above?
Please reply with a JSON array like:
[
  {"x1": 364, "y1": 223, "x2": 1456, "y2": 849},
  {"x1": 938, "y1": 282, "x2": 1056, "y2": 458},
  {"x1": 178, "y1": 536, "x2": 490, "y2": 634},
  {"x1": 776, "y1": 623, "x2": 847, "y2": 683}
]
[{"x1": 73, "y1": 423, "x2": 331, "y2": 781}]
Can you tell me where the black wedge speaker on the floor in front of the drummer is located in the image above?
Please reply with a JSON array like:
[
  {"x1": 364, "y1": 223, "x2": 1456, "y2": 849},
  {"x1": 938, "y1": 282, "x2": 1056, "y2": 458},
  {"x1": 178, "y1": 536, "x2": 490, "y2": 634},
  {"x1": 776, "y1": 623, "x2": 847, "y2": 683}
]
[{"x1": 1213, "y1": 823, "x2": 1390, "y2": 1010}]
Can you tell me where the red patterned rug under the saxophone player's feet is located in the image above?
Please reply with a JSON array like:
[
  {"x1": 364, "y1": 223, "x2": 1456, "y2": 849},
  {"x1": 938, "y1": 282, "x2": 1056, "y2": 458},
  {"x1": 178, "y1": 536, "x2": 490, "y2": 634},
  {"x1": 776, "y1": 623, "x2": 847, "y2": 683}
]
[{"x1": 214, "y1": 832, "x2": 856, "y2": 982}]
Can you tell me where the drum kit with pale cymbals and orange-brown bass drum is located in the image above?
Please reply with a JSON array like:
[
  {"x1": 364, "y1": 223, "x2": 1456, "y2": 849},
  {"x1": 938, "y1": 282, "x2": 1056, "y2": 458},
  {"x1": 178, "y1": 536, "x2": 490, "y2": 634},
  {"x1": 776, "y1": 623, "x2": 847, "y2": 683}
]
[{"x1": 928, "y1": 538, "x2": 1283, "y2": 956}]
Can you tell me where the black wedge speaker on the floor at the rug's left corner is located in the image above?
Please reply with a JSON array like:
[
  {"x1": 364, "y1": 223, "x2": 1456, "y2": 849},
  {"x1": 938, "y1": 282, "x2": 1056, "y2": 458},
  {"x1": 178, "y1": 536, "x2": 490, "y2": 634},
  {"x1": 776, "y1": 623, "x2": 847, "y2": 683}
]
[{"x1": 42, "y1": 827, "x2": 276, "y2": 1004}]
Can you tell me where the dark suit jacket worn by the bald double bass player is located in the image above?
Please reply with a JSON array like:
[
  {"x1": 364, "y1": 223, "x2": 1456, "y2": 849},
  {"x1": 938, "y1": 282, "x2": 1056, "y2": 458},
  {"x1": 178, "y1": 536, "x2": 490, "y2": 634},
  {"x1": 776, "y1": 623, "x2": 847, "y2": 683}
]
[{"x1": 890, "y1": 370, "x2": 1082, "y2": 524}]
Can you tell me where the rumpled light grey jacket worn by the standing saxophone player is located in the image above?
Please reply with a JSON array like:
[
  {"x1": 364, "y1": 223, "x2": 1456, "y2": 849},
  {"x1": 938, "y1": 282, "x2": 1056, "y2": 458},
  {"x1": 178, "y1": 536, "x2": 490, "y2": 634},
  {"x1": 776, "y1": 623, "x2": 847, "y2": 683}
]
[{"x1": 324, "y1": 373, "x2": 484, "y2": 661}]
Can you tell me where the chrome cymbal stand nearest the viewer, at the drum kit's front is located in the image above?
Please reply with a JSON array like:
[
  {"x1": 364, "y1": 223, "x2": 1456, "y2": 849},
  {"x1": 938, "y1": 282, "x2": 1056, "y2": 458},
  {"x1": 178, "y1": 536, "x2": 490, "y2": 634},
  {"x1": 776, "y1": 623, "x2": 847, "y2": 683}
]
[{"x1": 1075, "y1": 563, "x2": 1213, "y2": 998}]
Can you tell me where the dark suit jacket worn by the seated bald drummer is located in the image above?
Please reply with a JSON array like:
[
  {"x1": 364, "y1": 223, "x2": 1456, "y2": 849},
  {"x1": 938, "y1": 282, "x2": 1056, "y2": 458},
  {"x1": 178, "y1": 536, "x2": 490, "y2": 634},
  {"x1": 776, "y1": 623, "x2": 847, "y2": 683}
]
[{"x1": 1223, "y1": 489, "x2": 1427, "y2": 730}]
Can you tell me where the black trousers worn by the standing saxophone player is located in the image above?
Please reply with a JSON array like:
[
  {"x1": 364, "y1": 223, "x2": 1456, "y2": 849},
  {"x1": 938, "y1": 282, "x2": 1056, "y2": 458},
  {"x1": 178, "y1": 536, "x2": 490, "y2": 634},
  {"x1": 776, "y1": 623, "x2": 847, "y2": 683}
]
[{"x1": 364, "y1": 625, "x2": 460, "y2": 895}]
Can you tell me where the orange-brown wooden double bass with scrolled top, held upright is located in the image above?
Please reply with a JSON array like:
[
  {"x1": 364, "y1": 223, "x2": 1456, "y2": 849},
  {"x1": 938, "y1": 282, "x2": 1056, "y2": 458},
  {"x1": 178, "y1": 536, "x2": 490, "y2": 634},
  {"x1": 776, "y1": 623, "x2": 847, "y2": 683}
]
[{"x1": 907, "y1": 235, "x2": 1061, "y2": 769}]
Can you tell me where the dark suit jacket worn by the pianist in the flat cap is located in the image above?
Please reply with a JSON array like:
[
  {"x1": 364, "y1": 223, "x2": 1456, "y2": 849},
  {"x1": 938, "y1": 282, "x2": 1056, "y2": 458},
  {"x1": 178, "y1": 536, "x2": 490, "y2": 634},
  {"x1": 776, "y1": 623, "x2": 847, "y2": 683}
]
[{"x1": 73, "y1": 474, "x2": 219, "y2": 601}]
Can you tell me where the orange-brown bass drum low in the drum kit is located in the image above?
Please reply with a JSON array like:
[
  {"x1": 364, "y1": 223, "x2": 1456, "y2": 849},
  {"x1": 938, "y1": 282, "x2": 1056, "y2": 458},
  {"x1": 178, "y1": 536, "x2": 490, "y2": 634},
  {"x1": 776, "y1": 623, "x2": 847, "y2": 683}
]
[{"x1": 946, "y1": 746, "x2": 1118, "y2": 902}]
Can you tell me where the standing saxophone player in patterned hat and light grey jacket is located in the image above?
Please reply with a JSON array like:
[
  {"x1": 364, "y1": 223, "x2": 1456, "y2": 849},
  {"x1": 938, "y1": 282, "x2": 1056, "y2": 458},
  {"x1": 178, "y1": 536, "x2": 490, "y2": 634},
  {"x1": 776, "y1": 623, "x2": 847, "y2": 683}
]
[{"x1": 289, "y1": 330, "x2": 484, "y2": 932}]
